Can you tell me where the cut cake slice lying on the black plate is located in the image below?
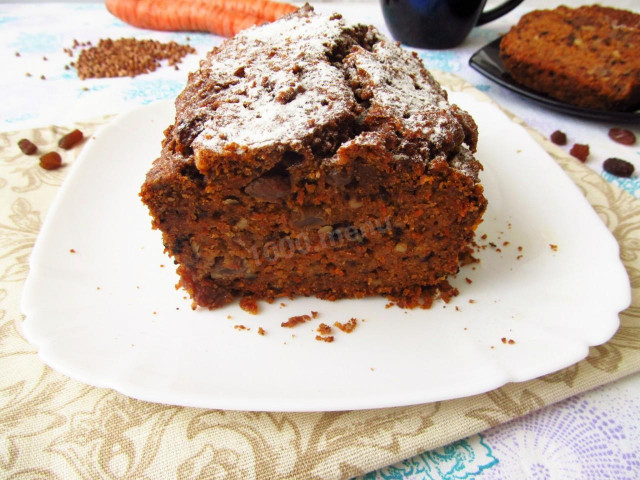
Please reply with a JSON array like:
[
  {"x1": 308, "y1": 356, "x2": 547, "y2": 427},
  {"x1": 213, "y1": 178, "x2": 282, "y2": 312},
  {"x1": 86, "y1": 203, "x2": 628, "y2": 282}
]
[{"x1": 500, "y1": 5, "x2": 640, "y2": 111}]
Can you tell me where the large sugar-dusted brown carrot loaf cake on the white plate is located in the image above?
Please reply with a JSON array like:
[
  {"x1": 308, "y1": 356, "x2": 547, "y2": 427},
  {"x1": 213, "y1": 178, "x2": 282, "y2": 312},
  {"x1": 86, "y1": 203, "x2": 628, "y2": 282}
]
[{"x1": 141, "y1": 6, "x2": 486, "y2": 308}]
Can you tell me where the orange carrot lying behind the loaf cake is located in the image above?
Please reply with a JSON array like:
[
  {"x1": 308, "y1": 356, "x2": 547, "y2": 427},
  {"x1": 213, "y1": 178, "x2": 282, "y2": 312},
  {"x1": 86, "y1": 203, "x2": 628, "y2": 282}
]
[{"x1": 106, "y1": 0, "x2": 297, "y2": 37}]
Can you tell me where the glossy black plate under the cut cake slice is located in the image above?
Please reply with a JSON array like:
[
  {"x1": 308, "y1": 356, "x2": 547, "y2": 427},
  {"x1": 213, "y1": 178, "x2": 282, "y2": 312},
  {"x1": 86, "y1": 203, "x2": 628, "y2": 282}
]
[{"x1": 469, "y1": 37, "x2": 640, "y2": 123}]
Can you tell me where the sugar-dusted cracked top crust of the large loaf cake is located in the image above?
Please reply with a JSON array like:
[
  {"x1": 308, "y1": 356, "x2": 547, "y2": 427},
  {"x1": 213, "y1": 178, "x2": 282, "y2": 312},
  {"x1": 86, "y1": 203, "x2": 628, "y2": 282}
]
[{"x1": 176, "y1": 7, "x2": 473, "y2": 171}]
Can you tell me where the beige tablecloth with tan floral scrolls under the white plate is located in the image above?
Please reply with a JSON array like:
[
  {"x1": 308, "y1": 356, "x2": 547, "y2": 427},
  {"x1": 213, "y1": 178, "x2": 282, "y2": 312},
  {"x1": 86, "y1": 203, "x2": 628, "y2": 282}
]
[{"x1": 0, "y1": 74, "x2": 640, "y2": 480}]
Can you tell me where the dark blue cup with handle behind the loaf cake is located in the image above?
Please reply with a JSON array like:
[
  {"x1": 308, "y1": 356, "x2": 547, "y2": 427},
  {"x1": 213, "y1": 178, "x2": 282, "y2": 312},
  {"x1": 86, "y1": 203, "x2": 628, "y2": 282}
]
[{"x1": 381, "y1": 0, "x2": 524, "y2": 48}]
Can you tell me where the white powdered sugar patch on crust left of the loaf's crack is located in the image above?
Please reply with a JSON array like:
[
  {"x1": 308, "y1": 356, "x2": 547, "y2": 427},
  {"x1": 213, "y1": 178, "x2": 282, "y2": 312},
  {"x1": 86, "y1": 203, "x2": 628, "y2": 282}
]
[{"x1": 194, "y1": 10, "x2": 355, "y2": 153}]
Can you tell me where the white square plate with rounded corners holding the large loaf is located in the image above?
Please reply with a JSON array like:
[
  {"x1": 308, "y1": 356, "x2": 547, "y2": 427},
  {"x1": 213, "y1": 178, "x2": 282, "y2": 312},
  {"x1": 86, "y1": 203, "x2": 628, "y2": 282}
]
[{"x1": 22, "y1": 93, "x2": 630, "y2": 411}]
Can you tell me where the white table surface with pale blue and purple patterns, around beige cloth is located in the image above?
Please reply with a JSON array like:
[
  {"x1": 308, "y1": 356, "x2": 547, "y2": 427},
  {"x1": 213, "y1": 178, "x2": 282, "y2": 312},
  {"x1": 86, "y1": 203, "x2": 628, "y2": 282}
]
[{"x1": 0, "y1": 0, "x2": 640, "y2": 480}]
